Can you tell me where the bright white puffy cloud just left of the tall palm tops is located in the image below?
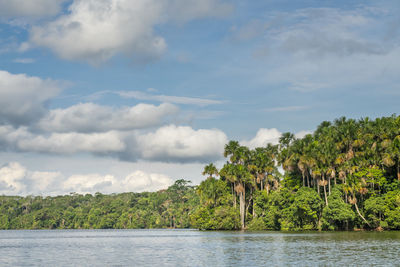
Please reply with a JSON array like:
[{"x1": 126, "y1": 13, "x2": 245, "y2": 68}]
[{"x1": 137, "y1": 125, "x2": 227, "y2": 162}]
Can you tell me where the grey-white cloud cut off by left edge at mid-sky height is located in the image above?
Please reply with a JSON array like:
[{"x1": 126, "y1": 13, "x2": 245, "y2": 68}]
[{"x1": 0, "y1": 70, "x2": 60, "y2": 125}]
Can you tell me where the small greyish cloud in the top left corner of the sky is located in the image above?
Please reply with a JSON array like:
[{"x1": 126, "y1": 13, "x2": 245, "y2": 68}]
[{"x1": 0, "y1": 0, "x2": 66, "y2": 18}]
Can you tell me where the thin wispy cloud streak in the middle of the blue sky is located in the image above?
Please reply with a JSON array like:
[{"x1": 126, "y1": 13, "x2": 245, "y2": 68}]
[{"x1": 118, "y1": 91, "x2": 223, "y2": 106}]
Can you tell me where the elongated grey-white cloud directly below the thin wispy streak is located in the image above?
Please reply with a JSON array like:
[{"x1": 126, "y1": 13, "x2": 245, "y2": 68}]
[{"x1": 37, "y1": 103, "x2": 178, "y2": 133}]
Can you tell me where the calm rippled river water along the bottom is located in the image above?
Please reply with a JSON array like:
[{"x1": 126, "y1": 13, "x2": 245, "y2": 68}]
[{"x1": 0, "y1": 230, "x2": 400, "y2": 266}]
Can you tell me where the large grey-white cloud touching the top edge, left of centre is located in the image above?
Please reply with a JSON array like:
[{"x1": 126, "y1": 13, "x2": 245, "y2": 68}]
[{"x1": 30, "y1": 0, "x2": 228, "y2": 65}]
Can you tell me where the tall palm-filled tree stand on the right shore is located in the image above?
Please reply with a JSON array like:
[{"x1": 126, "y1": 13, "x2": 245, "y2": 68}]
[{"x1": 192, "y1": 115, "x2": 400, "y2": 230}]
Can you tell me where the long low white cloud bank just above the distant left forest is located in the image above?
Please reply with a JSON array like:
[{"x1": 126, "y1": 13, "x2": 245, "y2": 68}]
[{"x1": 0, "y1": 162, "x2": 173, "y2": 195}]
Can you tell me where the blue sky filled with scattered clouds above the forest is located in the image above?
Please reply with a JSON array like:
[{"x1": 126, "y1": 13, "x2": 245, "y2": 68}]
[{"x1": 0, "y1": 0, "x2": 400, "y2": 196}]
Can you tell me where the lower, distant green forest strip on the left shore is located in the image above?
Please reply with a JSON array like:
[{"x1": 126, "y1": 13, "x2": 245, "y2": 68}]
[{"x1": 0, "y1": 180, "x2": 199, "y2": 229}]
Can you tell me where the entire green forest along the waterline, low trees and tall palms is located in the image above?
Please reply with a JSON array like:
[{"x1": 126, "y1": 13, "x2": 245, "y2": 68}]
[{"x1": 0, "y1": 115, "x2": 400, "y2": 230}]
